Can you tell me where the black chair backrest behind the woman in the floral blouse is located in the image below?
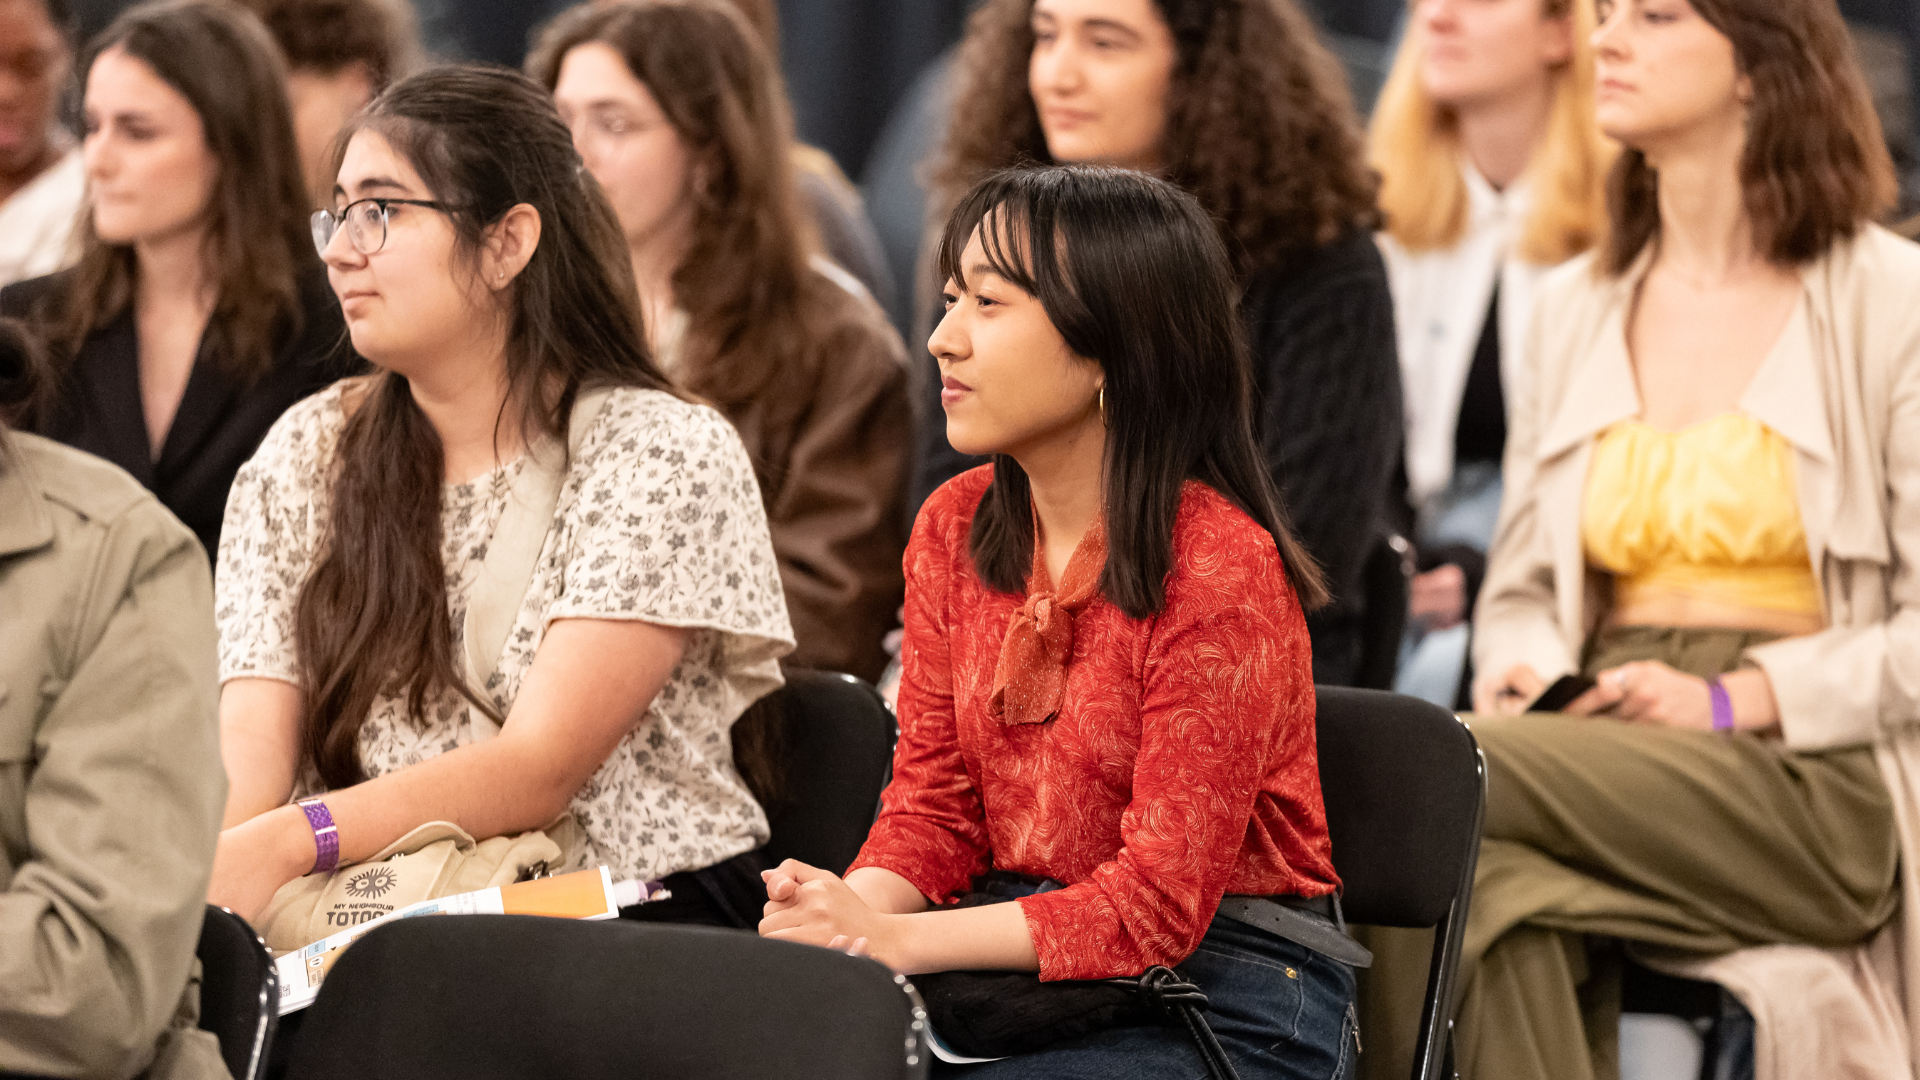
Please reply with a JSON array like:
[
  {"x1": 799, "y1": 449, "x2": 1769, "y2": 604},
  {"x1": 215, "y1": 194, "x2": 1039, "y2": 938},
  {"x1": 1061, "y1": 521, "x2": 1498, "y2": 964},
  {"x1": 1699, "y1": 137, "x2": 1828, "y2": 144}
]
[{"x1": 766, "y1": 669, "x2": 897, "y2": 874}]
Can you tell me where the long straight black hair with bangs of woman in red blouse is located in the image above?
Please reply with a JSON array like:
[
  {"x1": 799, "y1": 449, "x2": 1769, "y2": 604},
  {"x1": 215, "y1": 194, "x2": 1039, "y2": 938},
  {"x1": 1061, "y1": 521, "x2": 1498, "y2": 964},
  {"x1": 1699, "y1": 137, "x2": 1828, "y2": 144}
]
[{"x1": 939, "y1": 165, "x2": 1327, "y2": 619}]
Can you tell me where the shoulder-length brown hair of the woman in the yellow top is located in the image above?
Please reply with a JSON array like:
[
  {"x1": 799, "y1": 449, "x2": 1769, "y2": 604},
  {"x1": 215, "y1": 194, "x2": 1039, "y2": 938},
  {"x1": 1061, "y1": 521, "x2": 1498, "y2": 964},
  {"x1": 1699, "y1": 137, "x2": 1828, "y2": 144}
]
[{"x1": 1603, "y1": 0, "x2": 1897, "y2": 275}]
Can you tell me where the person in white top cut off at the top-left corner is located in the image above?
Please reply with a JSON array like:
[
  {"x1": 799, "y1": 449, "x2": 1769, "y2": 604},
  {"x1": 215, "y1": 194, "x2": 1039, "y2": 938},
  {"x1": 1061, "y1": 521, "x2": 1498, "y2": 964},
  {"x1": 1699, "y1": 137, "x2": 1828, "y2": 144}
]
[{"x1": 0, "y1": 0, "x2": 86, "y2": 284}]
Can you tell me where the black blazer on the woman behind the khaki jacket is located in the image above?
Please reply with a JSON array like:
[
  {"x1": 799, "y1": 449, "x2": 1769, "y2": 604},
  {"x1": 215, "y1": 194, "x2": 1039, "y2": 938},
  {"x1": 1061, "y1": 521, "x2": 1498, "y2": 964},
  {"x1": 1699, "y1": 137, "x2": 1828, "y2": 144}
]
[{"x1": 0, "y1": 265, "x2": 361, "y2": 561}]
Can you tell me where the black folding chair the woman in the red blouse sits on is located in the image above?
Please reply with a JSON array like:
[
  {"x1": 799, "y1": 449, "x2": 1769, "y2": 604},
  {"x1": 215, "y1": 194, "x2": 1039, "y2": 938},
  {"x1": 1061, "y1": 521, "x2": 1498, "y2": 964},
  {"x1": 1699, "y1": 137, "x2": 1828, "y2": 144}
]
[{"x1": 1315, "y1": 686, "x2": 1486, "y2": 1080}]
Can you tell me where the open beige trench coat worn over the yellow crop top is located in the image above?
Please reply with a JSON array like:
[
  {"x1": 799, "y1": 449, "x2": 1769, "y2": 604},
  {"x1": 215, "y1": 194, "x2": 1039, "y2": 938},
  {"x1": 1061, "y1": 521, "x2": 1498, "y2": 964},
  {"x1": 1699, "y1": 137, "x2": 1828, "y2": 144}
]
[{"x1": 1475, "y1": 229, "x2": 1920, "y2": 1080}]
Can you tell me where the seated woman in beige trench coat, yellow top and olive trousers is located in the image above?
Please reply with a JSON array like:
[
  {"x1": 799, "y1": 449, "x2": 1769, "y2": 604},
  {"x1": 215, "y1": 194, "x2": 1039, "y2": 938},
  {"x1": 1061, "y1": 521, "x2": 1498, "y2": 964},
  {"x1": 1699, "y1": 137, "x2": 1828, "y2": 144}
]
[{"x1": 1369, "y1": 0, "x2": 1920, "y2": 1080}]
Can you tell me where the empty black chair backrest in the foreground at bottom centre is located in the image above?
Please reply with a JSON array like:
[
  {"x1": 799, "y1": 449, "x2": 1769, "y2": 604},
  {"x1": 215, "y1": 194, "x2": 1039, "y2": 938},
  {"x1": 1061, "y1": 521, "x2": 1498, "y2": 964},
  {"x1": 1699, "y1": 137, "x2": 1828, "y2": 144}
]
[{"x1": 286, "y1": 915, "x2": 927, "y2": 1080}]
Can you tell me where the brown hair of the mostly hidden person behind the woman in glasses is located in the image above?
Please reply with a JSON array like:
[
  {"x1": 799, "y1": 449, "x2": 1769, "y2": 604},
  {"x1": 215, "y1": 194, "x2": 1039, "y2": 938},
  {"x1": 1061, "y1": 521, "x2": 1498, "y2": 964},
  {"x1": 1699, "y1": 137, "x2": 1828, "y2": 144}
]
[{"x1": 240, "y1": 0, "x2": 420, "y2": 92}]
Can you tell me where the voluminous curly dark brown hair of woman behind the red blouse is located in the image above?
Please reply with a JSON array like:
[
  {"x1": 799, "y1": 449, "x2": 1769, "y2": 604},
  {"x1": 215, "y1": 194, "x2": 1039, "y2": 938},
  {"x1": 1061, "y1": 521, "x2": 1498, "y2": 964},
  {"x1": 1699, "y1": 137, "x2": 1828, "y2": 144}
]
[{"x1": 935, "y1": 0, "x2": 1379, "y2": 279}]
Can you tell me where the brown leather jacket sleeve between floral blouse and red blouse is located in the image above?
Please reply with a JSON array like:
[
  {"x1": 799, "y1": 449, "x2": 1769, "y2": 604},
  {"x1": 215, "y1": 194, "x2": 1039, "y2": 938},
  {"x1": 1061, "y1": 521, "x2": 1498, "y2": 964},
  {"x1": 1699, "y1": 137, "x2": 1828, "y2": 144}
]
[{"x1": 766, "y1": 315, "x2": 912, "y2": 680}]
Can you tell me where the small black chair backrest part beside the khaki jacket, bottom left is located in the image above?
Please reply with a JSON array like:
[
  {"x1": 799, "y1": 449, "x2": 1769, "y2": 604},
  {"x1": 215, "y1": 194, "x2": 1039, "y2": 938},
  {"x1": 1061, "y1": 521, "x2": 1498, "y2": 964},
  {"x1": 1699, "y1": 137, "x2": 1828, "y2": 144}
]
[{"x1": 194, "y1": 903, "x2": 280, "y2": 1080}]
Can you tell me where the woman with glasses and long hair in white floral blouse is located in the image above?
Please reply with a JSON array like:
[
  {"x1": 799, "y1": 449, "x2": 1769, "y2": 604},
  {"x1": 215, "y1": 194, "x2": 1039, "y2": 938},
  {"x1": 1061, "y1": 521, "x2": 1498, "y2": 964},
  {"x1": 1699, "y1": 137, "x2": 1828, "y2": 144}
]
[{"x1": 209, "y1": 67, "x2": 793, "y2": 920}]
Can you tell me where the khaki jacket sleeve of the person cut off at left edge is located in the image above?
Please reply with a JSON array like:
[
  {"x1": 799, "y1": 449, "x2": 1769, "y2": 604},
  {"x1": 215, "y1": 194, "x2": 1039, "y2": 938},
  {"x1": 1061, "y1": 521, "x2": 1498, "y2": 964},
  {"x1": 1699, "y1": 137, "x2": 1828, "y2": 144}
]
[{"x1": 0, "y1": 502, "x2": 227, "y2": 1078}]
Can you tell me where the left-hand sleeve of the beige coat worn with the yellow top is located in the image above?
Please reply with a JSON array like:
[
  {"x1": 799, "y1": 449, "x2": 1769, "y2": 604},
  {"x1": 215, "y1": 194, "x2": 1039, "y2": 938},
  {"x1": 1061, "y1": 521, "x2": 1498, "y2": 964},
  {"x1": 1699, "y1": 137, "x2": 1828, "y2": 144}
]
[{"x1": 1473, "y1": 274, "x2": 1578, "y2": 688}]
